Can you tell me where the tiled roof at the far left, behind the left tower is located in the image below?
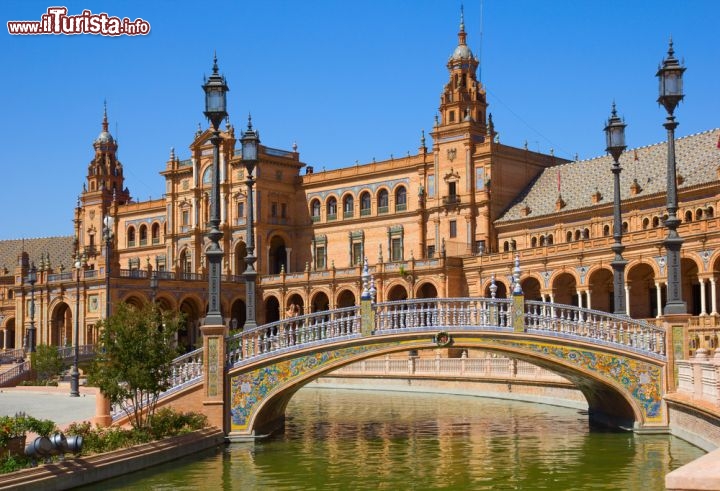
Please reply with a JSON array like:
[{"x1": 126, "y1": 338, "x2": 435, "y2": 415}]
[{"x1": 0, "y1": 235, "x2": 74, "y2": 276}]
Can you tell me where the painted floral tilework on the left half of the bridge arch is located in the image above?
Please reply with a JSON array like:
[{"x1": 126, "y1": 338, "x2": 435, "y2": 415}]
[{"x1": 230, "y1": 342, "x2": 399, "y2": 431}]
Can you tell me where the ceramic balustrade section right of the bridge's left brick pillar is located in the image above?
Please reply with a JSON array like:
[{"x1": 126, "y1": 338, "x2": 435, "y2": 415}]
[{"x1": 227, "y1": 306, "x2": 360, "y2": 366}]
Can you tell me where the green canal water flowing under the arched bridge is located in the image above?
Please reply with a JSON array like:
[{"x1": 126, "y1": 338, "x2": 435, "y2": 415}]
[{"x1": 83, "y1": 388, "x2": 705, "y2": 491}]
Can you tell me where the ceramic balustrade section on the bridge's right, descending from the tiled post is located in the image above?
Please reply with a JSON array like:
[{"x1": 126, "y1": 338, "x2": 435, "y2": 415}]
[{"x1": 525, "y1": 300, "x2": 666, "y2": 358}]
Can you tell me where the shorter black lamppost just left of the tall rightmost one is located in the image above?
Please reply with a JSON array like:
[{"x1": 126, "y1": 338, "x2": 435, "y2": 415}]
[{"x1": 605, "y1": 102, "x2": 627, "y2": 315}]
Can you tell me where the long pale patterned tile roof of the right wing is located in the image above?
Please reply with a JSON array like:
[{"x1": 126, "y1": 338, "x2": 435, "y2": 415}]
[{"x1": 496, "y1": 128, "x2": 720, "y2": 223}]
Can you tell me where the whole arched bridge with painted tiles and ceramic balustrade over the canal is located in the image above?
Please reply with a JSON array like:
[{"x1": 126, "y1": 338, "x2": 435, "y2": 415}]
[{"x1": 136, "y1": 295, "x2": 674, "y2": 439}]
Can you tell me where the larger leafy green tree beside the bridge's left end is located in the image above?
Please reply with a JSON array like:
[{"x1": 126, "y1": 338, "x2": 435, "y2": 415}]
[{"x1": 88, "y1": 304, "x2": 183, "y2": 428}]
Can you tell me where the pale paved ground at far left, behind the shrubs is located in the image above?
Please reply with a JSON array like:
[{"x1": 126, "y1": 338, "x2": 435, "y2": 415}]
[{"x1": 0, "y1": 384, "x2": 97, "y2": 428}]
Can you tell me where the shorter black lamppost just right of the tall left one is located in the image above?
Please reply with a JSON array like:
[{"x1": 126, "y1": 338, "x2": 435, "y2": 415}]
[{"x1": 240, "y1": 116, "x2": 260, "y2": 329}]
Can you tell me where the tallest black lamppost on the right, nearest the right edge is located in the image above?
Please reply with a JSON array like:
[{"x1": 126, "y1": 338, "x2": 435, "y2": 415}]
[{"x1": 655, "y1": 39, "x2": 687, "y2": 315}]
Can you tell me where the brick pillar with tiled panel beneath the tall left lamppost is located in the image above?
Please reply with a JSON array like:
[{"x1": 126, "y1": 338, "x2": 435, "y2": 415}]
[{"x1": 200, "y1": 325, "x2": 228, "y2": 433}]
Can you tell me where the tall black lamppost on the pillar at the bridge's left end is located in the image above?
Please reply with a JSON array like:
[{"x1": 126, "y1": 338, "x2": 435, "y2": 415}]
[{"x1": 202, "y1": 56, "x2": 230, "y2": 326}]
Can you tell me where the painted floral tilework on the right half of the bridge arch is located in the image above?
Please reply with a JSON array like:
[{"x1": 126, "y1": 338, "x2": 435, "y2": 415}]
[{"x1": 493, "y1": 339, "x2": 663, "y2": 422}]
